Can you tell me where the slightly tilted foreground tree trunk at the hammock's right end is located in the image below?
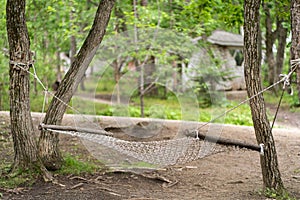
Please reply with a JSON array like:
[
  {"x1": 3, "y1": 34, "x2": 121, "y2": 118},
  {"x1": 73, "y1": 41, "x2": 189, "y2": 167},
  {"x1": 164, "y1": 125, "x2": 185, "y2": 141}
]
[{"x1": 244, "y1": 0, "x2": 283, "y2": 192}]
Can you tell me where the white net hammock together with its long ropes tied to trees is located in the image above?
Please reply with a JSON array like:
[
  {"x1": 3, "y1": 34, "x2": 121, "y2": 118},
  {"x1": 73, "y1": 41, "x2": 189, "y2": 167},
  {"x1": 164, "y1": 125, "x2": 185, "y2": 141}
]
[{"x1": 10, "y1": 60, "x2": 300, "y2": 165}]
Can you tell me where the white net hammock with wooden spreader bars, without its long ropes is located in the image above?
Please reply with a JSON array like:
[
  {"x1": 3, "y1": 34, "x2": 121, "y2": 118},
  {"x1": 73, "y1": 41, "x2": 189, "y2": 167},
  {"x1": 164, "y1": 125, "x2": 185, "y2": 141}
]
[{"x1": 40, "y1": 124, "x2": 262, "y2": 166}]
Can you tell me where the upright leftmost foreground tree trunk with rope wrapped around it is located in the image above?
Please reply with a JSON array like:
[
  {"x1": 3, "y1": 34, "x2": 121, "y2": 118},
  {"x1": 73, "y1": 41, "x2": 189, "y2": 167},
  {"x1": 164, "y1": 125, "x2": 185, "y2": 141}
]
[{"x1": 6, "y1": 0, "x2": 39, "y2": 172}]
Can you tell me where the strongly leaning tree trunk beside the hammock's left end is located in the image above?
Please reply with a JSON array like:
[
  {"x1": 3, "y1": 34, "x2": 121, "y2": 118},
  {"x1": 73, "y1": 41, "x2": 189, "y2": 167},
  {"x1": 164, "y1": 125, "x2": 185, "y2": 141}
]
[{"x1": 39, "y1": 0, "x2": 115, "y2": 170}]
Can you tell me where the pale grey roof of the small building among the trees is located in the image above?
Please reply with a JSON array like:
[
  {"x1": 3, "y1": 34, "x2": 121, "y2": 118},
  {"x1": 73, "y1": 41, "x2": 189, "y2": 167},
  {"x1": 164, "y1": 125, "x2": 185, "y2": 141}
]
[{"x1": 207, "y1": 30, "x2": 244, "y2": 47}]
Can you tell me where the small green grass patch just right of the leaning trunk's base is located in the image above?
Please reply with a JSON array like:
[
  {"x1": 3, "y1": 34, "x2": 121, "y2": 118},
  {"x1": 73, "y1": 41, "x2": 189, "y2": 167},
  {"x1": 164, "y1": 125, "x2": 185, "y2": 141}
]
[{"x1": 58, "y1": 154, "x2": 101, "y2": 175}]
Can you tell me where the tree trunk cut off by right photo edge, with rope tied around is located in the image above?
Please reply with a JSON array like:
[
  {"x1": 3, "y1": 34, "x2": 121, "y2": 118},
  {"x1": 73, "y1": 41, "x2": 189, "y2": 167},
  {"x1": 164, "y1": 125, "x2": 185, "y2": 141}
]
[{"x1": 291, "y1": 0, "x2": 300, "y2": 101}]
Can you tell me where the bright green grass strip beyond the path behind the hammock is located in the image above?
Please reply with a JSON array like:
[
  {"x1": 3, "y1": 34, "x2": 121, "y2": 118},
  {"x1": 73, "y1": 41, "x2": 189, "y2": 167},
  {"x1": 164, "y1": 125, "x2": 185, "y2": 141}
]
[{"x1": 72, "y1": 98, "x2": 253, "y2": 126}]
